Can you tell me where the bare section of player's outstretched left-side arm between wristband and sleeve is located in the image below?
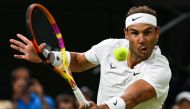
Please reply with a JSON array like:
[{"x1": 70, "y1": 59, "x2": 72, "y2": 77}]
[{"x1": 70, "y1": 52, "x2": 96, "y2": 72}]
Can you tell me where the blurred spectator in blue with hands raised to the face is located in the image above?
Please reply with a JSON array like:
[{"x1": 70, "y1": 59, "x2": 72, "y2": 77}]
[{"x1": 12, "y1": 67, "x2": 55, "y2": 109}]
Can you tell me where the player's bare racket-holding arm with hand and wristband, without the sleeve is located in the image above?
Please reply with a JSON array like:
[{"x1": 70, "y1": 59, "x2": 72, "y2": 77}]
[{"x1": 97, "y1": 79, "x2": 156, "y2": 109}]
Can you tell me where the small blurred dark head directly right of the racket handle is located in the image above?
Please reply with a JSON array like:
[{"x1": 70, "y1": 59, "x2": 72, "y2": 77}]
[{"x1": 80, "y1": 86, "x2": 93, "y2": 101}]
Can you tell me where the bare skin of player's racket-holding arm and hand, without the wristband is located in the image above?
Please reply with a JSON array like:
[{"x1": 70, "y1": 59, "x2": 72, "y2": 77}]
[{"x1": 97, "y1": 80, "x2": 156, "y2": 109}]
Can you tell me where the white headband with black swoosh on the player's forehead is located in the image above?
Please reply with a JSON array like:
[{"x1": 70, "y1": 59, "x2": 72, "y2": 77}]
[{"x1": 125, "y1": 13, "x2": 157, "y2": 28}]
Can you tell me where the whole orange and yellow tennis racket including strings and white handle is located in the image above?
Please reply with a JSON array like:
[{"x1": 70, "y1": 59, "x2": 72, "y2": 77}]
[{"x1": 26, "y1": 3, "x2": 89, "y2": 107}]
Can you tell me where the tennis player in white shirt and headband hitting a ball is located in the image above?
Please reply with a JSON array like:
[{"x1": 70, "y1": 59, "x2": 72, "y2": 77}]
[{"x1": 10, "y1": 6, "x2": 171, "y2": 109}]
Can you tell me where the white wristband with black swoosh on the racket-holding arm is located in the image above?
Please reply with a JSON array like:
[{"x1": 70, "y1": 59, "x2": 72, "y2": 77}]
[{"x1": 105, "y1": 97, "x2": 126, "y2": 109}]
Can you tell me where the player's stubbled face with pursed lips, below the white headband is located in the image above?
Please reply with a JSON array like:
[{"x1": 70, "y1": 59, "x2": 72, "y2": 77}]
[{"x1": 125, "y1": 23, "x2": 160, "y2": 60}]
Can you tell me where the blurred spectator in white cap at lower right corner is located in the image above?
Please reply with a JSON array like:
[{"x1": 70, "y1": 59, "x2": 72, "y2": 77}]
[{"x1": 172, "y1": 92, "x2": 190, "y2": 109}]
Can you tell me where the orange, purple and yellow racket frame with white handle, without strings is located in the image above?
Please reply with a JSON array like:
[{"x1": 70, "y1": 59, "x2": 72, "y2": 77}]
[{"x1": 26, "y1": 3, "x2": 89, "y2": 107}]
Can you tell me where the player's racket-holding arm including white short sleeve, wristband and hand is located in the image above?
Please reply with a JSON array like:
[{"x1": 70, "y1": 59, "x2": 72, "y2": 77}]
[{"x1": 86, "y1": 67, "x2": 171, "y2": 109}]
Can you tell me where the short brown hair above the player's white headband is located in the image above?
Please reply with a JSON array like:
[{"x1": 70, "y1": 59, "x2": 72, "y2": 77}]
[{"x1": 127, "y1": 6, "x2": 157, "y2": 17}]
